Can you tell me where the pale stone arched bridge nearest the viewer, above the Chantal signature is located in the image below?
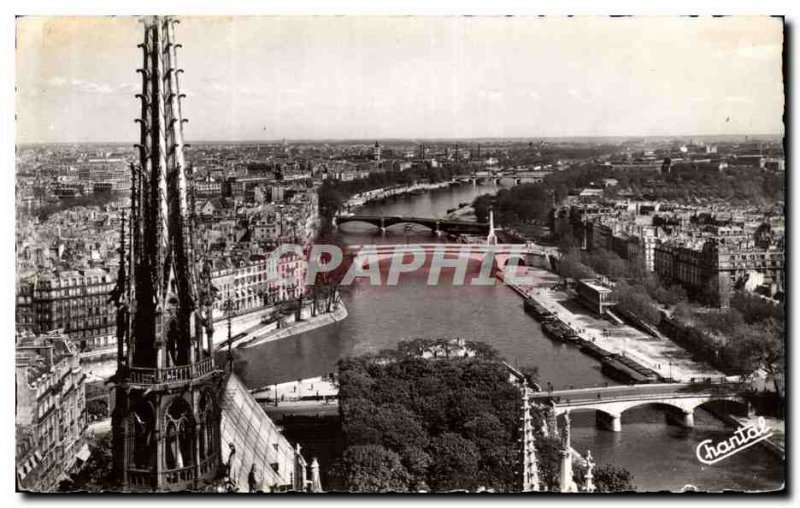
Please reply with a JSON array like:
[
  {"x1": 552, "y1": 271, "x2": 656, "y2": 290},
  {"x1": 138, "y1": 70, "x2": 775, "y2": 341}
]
[{"x1": 531, "y1": 383, "x2": 750, "y2": 432}]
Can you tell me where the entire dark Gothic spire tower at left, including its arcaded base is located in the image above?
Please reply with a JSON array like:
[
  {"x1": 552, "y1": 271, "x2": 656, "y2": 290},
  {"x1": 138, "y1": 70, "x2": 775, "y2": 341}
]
[{"x1": 112, "y1": 17, "x2": 221, "y2": 491}]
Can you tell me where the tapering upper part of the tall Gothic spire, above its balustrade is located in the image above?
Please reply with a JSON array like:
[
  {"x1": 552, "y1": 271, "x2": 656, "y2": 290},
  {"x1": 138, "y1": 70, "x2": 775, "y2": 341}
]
[{"x1": 131, "y1": 17, "x2": 209, "y2": 368}]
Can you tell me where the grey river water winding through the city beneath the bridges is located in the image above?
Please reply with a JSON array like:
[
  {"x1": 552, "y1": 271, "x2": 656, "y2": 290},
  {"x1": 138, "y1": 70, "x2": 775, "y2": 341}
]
[{"x1": 234, "y1": 185, "x2": 783, "y2": 491}]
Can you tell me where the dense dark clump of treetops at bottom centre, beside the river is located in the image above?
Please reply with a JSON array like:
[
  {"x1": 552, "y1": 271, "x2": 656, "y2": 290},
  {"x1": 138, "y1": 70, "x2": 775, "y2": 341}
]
[{"x1": 332, "y1": 339, "x2": 520, "y2": 492}]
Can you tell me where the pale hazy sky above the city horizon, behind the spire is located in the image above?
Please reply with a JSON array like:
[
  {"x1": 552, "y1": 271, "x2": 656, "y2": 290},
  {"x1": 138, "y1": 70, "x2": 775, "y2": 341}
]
[{"x1": 16, "y1": 16, "x2": 784, "y2": 143}]
